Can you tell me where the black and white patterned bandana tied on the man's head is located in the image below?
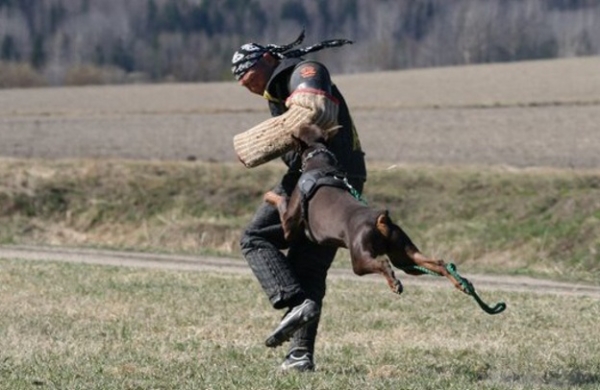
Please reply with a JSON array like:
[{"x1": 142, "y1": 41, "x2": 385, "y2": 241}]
[{"x1": 231, "y1": 30, "x2": 352, "y2": 80}]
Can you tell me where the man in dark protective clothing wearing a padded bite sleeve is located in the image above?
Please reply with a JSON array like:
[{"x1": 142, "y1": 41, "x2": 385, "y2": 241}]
[{"x1": 232, "y1": 31, "x2": 366, "y2": 371}]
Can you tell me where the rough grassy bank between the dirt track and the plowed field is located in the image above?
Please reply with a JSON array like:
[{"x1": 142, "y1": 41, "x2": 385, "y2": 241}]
[{"x1": 0, "y1": 160, "x2": 600, "y2": 283}]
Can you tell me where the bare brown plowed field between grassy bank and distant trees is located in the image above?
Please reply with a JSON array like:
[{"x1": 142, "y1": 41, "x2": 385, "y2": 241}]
[{"x1": 0, "y1": 57, "x2": 600, "y2": 169}]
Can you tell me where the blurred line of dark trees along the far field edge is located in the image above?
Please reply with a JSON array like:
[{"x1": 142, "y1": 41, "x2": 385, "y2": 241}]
[{"x1": 0, "y1": 0, "x2": 600, "y2": 87}]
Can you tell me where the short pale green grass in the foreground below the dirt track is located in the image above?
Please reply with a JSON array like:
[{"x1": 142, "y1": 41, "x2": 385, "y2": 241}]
[{"x1": 0, "y1": 260, "x2": 600, "y2": 390}]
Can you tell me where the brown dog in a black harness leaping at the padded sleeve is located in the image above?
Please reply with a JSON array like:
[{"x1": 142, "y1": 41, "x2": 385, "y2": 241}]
[{"x1": 264, "y1": 125, "x2": 467, "y2": 294}]
